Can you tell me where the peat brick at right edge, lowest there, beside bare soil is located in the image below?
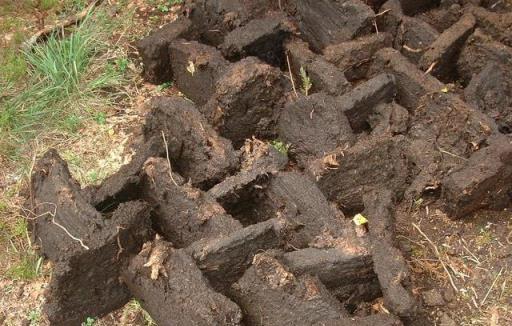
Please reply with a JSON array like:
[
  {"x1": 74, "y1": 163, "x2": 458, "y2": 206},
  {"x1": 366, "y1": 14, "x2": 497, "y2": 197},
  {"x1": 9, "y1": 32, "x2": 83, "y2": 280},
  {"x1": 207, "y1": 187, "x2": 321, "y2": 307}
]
[{"x1": 443, "y1": 135, "x2": 512, "y2": 217}]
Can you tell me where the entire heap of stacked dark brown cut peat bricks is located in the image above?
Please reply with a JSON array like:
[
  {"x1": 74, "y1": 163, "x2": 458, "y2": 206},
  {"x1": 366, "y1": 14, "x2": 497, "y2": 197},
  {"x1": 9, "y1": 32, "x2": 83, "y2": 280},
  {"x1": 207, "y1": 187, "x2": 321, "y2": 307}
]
[{"x1": 26, "y1": 0, "x2": 512, "y2": 326}]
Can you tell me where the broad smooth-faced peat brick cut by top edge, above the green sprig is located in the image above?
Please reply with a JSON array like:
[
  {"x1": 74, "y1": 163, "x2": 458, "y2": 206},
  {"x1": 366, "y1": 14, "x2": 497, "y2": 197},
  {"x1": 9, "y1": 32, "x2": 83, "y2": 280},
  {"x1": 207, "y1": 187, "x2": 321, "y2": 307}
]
[{"x1": 297, "y1": 0, "x2": 375, "y2": 51}]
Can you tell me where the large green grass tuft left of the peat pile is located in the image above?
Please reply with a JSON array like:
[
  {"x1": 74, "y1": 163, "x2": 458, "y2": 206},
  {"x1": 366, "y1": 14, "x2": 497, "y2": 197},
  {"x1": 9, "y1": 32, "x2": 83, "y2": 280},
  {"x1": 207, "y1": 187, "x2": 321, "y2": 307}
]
[{"x1": 0, "y1": 12, "x2": 127, "y2": 158}]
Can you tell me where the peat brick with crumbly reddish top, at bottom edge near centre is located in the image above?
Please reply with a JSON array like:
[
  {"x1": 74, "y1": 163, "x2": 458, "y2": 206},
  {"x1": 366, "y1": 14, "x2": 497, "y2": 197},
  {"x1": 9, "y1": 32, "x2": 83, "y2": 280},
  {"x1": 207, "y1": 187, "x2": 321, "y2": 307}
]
[{"x1": 231, "y1": 254, "x2": 346, "y2": 326}]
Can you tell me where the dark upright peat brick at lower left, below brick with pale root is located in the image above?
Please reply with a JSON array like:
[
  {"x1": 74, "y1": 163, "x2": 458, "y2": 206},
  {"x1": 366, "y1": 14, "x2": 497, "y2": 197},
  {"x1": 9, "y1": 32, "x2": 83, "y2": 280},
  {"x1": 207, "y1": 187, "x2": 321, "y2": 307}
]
[{"x1": 44, "y1": 201, "x2": 152, "y2": 326}]
